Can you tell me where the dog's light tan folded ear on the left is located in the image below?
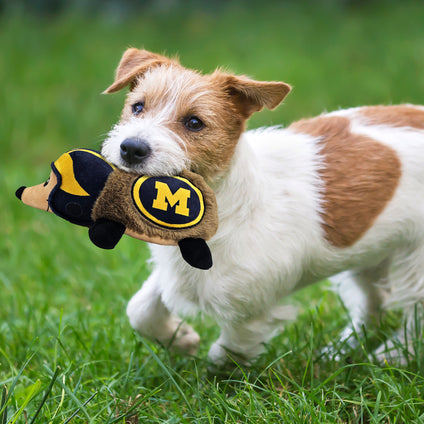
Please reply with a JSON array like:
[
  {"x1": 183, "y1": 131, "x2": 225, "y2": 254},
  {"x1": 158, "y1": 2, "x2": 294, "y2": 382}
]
[{"x1": 103, "y1": 48, "x2": 176, "y2": 94}]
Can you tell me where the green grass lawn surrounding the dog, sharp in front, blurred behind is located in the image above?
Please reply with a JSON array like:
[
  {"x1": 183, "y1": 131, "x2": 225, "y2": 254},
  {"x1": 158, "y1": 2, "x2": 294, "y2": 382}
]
[{"x1": 0, "y1": 1, "x2": 424, "y2": 424}]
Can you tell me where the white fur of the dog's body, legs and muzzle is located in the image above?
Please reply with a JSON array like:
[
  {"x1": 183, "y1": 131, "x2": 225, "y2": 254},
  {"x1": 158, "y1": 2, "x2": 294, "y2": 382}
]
[{"x1": 107, "y1": 102, "x2": 424, "y2": 364}]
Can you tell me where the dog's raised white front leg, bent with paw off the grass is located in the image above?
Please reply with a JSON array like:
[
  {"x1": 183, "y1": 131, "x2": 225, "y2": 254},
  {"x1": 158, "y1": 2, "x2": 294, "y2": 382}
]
[{"x1": 127, "y1": 271, "x2": 200, "y2": 355}]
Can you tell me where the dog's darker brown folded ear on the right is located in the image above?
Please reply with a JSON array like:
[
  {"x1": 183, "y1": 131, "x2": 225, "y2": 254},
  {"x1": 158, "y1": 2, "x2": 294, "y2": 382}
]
[{"x1": 213, "y1": 71, "x2": 291, "y2": 118}]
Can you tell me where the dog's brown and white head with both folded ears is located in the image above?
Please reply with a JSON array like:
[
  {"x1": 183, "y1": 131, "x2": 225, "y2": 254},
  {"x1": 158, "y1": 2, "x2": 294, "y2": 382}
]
[{"x1": 102, "y1": 48, "x2": 290, "y2": 179}]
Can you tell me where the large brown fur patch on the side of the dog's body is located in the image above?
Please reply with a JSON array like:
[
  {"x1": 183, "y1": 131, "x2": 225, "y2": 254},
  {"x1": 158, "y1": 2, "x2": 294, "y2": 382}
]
[{"x1": 290, "y1": 116, "x2": 401, "y2": 247}]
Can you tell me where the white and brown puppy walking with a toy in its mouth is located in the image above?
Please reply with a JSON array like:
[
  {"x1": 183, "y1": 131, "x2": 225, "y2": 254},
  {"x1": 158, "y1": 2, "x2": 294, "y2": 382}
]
[{"x1": 102, "y1": 48, "x2": 424, "y2": 365}]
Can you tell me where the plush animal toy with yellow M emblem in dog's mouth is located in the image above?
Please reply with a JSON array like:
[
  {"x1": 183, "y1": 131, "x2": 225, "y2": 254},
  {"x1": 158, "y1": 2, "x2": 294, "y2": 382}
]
[{"x1": 16, "y1": 149, "x2": 218, "y2": 269}]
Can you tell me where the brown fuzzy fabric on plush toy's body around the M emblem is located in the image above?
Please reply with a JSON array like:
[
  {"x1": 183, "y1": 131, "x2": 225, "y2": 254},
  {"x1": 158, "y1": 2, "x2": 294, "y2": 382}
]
[{"x1": 92, "y1": 169, "x2": 218, "y2": 245}]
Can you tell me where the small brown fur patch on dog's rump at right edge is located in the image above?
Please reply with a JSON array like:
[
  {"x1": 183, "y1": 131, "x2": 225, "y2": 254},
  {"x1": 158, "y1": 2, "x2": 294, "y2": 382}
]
[{"x1": 359, "y1": 105, "x2": 424, "y2": 130}]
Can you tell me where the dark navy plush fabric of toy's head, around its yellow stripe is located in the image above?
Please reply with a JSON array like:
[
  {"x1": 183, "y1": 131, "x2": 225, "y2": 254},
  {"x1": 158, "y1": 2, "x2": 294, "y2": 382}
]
[{"x1": 49, "y1": 149, "x2": 113, "y2": 227}]
